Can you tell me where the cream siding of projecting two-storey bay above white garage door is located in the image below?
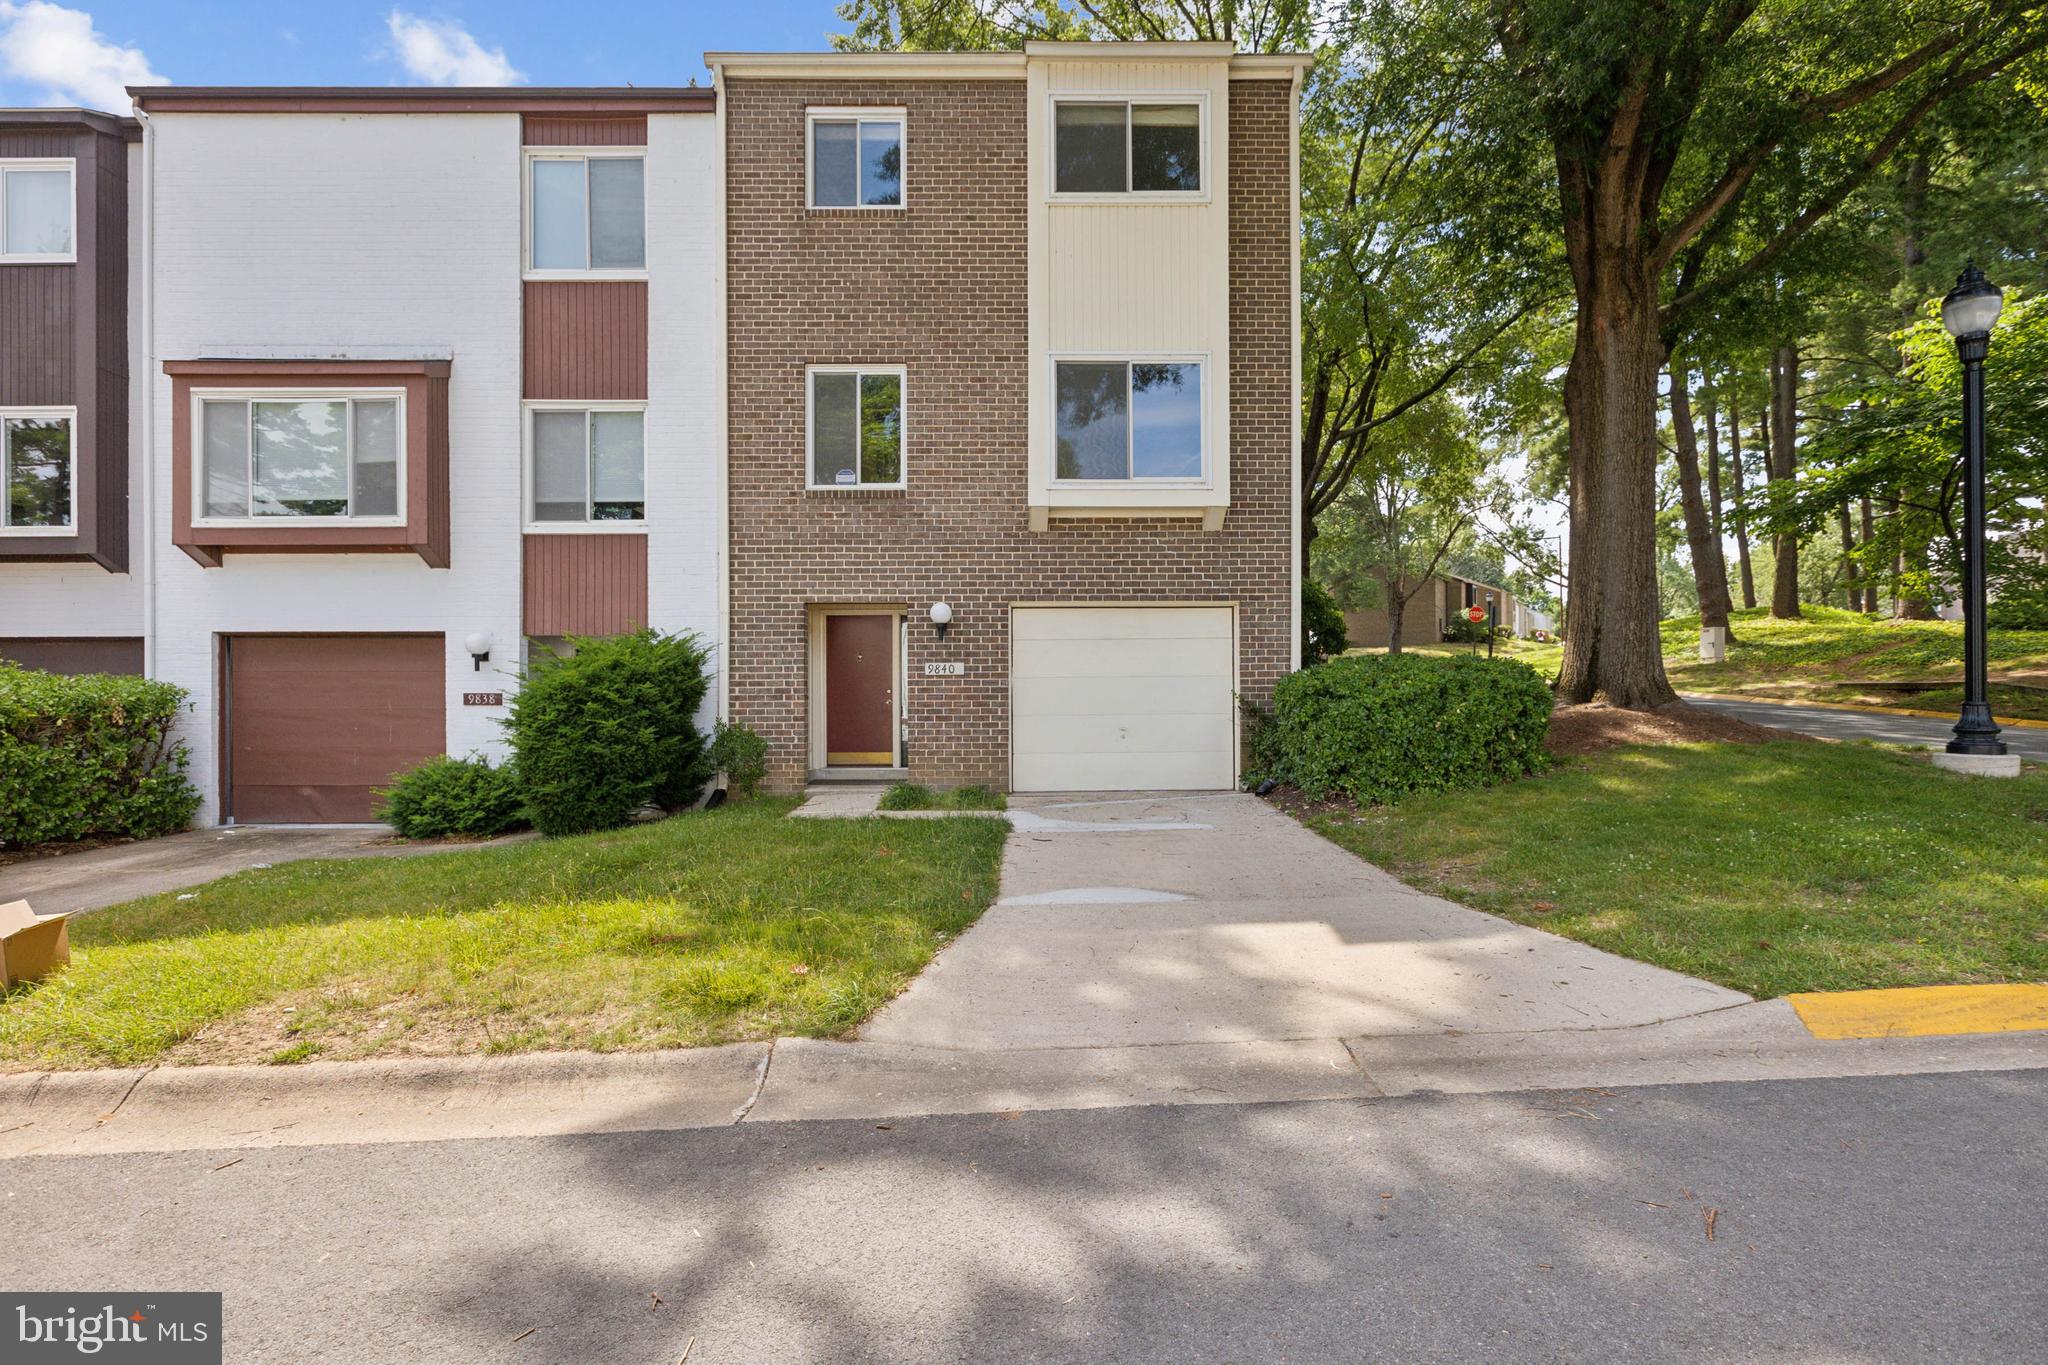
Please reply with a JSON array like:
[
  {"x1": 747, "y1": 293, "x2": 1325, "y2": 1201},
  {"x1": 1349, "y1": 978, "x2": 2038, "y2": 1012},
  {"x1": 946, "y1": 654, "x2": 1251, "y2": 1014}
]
[{"x1": 1028, "y1": 57, "x2": 1231, "y2": 526}]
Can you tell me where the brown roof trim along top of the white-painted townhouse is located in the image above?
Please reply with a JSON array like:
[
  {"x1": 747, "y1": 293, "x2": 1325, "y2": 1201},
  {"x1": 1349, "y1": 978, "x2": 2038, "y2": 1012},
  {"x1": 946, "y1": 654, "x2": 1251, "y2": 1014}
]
[{"x1": 129, "y1": 86, "x2": 719, "y2": 115}]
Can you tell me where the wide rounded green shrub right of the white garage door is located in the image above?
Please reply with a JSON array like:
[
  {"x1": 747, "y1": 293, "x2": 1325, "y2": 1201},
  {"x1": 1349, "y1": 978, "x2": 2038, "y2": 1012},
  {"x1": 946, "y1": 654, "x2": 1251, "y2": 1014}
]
[{"x1": 1260, "y1": 655, "x2": 1550, "y2": 802}]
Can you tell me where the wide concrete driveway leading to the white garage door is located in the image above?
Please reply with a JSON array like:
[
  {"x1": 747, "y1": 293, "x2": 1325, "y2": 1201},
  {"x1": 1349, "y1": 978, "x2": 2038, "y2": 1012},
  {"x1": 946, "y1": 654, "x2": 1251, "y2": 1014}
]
[{"x1": 860, "y1": 792, "x2": 1749, "y2": 1050}]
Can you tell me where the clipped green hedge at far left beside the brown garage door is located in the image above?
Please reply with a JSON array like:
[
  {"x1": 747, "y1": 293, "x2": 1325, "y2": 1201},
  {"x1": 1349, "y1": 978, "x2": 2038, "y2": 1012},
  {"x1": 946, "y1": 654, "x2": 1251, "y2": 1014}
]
[{"x1": 0, "y1": 663, "x2": 199, "y2": 847}]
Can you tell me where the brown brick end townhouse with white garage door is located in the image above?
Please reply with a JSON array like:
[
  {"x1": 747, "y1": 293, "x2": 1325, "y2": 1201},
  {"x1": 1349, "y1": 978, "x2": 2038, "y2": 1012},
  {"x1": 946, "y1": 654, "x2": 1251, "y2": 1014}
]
[{"x1": 707, "y1": 43, "x2": 1305, "y2": 790}]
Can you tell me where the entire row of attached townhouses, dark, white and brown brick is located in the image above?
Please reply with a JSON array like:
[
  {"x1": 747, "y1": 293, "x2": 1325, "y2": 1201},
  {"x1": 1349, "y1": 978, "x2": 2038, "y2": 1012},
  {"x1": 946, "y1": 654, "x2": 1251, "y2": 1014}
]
[{"x1": 0, "y1": 43, "x2": 1305, "y2": 823}]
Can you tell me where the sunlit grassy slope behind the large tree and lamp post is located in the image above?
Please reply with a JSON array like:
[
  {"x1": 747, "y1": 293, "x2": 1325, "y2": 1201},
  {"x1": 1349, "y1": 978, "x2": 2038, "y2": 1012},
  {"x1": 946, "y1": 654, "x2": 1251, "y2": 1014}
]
[{"x1": 1663, "y1": 606, "x2": 2048, "y2": 720}]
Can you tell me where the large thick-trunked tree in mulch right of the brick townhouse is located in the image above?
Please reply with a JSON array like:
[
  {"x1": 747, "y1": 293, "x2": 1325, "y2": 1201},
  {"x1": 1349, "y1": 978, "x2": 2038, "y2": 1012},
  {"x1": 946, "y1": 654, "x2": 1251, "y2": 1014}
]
[{"x1": 1491, "y1": 0, "x2": 2048, "y2": 706}]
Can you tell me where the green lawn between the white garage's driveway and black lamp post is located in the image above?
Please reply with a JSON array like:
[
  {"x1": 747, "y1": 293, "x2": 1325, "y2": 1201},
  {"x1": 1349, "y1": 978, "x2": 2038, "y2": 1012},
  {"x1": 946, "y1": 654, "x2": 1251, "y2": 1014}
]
[{"x1": 1305, "y1": 743, "x2": 2048, "y2": 997}]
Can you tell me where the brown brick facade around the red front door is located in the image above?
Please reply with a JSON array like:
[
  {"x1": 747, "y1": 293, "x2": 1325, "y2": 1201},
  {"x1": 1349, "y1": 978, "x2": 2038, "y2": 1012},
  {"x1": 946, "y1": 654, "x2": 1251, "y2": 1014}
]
[{"x1": 725, "y1": 80, "x2": 1294, "y2": 790}]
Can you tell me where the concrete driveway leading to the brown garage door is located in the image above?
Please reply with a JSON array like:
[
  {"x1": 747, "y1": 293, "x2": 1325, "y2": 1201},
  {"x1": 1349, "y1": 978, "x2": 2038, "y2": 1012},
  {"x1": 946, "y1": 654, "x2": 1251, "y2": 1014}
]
[{"x1": 0, "y1": 825, "x2": 520, "y2": 915}]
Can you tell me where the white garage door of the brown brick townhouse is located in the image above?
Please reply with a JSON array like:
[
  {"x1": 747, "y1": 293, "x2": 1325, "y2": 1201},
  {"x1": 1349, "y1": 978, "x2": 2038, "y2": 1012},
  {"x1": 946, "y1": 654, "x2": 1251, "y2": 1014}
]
[{"x1": 1010, "y1": 606, "x2": 1237, "y2": 792}]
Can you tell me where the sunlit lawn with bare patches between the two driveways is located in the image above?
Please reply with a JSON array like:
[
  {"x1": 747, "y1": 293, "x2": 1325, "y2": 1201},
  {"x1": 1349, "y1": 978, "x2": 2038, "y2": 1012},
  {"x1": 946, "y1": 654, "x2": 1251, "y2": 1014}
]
[{"x1": 0, "y1": 800, "x2": 1008, "y2": 1068}]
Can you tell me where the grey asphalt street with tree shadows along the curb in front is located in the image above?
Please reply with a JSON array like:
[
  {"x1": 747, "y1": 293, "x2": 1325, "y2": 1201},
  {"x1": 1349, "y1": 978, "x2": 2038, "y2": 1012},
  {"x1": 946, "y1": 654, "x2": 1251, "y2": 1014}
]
[{"x1": 0, "y1": 1070, "x2": 2048, "y2": 1365}]
